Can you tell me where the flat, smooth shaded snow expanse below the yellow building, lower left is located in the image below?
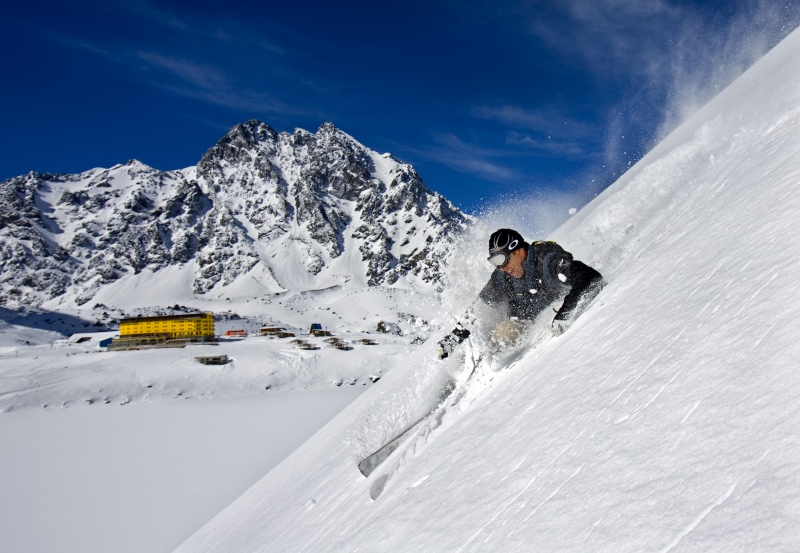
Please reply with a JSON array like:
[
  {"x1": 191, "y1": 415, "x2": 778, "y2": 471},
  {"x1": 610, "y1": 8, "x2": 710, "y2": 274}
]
[{"x1": 0, "y1": 386, "x2": 361, "y2": 553}]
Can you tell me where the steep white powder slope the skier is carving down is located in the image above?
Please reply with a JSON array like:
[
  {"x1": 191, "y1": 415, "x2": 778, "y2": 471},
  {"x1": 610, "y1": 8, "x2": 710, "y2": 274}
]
[{"x1": 173, "y1": 31, "x2": 800, "y2": 553}]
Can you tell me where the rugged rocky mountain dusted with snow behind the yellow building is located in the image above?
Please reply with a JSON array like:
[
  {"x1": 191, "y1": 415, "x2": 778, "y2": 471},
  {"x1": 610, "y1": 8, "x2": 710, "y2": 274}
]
[{"x1": 0, "y1": 120, "x2": 468, "y2": 309}]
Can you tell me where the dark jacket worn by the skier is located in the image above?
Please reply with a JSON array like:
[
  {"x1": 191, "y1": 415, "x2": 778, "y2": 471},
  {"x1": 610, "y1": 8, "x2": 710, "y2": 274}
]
[{"x1": 479, "y1": 242, "x2": 603, "y2": 320}]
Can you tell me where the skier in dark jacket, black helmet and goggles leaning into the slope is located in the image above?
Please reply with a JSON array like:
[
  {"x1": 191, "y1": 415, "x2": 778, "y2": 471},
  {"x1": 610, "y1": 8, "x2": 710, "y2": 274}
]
[{"x1": 439, "y1": 229, "x2": 605, "y2": 359}]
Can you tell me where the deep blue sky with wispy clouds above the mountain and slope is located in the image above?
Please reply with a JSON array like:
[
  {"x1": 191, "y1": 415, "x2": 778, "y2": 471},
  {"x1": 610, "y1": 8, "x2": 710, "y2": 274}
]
[{"x1": 0, "y1": 0, "x2": 800, "y2": 212}]
